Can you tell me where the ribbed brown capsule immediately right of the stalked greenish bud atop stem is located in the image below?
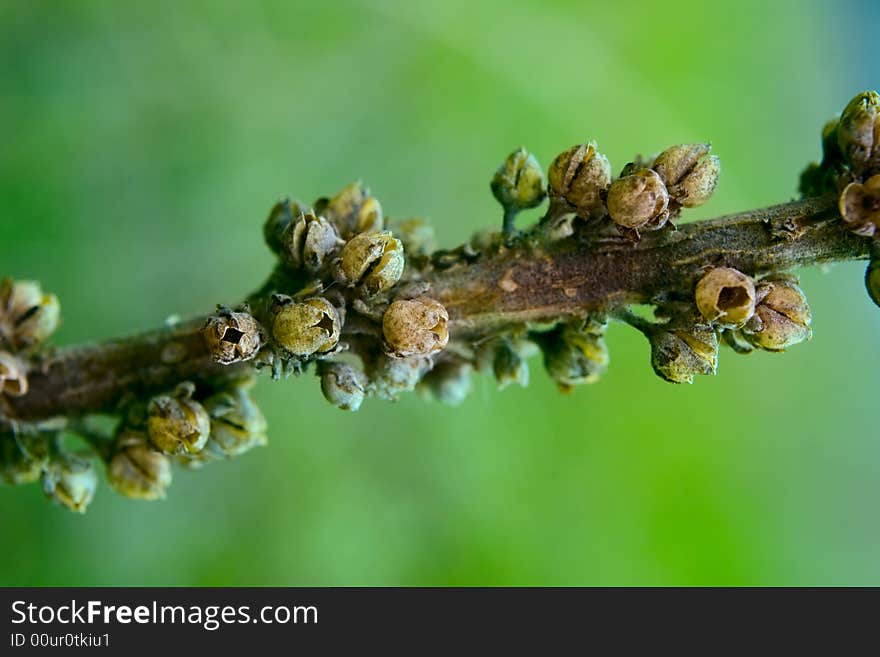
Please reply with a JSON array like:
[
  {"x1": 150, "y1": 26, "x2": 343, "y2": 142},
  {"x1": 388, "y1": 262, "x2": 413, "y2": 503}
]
[{"x1": 548, "y1": 142, "x2": 611, "y2": 216}]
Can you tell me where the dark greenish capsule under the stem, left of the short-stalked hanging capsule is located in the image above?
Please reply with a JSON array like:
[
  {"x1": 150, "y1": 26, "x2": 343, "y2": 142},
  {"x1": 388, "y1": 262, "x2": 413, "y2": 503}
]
[{"x1": 541, "y1": 321, "x2": 609, "y2": 390}]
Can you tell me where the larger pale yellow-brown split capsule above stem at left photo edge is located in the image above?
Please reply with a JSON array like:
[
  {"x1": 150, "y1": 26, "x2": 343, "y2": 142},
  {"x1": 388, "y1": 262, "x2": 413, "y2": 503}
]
[{"x1": 0, "y1": 278, "x2": 61, "y2": 351}]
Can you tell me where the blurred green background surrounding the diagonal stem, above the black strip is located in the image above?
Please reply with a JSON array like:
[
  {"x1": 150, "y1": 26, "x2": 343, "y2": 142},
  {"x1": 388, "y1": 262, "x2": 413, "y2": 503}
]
[{"x1": 0, "y1": 0, "x2": 880, "y2": 585}]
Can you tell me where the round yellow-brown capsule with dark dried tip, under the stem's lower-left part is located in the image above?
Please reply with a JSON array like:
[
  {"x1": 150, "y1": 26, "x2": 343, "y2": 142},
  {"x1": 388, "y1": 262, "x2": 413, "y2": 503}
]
[{"x1": 147, "y1": 383, "x2": 211, "y2": 454}]
